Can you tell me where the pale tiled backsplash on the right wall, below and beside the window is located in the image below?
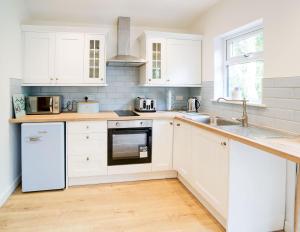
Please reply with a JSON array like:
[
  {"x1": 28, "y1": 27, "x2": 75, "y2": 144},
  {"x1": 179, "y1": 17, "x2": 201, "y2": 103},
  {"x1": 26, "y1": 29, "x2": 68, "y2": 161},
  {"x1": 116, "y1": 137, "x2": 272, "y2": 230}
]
[{"x1": 201, "y1": 77, "x2": 300, "y2": 133}]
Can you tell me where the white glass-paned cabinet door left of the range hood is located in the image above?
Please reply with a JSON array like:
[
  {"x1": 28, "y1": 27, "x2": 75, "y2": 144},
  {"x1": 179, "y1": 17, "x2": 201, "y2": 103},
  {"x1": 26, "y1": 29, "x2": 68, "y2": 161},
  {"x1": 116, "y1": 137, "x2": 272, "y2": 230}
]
[{"x1": 84, "y1": 34, "x2": 106, "y2": 84}]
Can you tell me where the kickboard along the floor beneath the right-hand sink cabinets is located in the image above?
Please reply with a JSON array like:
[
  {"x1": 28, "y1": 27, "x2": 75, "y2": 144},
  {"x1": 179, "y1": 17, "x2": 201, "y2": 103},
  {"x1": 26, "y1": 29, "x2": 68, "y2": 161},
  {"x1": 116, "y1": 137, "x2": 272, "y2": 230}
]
[{"x1": 178, "y1": 174, "x2": 227, "y2": 228}]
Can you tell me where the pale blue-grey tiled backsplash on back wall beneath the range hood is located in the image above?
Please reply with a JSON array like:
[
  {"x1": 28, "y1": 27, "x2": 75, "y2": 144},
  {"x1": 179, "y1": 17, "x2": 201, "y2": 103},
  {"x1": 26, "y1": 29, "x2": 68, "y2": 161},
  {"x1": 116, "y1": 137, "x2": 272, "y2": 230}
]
[{"x1": 30, "y1": 67, "x2": 199, "y2": 111}]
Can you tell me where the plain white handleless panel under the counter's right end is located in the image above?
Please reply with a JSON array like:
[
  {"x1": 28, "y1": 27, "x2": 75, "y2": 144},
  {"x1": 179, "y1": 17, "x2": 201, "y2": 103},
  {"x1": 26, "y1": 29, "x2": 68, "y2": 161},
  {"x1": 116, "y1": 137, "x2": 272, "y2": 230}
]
[{"x1": 227, "y1": 141, "x2": 287, "y2": 232}]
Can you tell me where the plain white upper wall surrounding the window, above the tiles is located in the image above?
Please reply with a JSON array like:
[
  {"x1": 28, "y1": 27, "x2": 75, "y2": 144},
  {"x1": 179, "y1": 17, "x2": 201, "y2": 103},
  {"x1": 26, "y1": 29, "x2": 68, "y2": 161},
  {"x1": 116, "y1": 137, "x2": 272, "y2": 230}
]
[{"x1": 191, "y1": 0, "x2": 300, "y2": 81}]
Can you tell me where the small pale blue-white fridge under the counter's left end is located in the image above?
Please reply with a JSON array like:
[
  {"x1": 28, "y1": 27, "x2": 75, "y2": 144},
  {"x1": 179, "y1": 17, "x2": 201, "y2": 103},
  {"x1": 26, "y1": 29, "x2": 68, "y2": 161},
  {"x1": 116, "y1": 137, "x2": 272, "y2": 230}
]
[{"x1": 21, "y1": 122, "x2": 66, "y2": 192}]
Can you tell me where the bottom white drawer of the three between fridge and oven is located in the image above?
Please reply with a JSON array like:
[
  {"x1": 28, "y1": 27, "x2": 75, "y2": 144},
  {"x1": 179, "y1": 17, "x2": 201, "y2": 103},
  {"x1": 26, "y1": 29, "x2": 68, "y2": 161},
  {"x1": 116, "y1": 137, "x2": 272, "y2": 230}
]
[{"x1": 68, "y1": 154, "x2": 107, "y2": 177}]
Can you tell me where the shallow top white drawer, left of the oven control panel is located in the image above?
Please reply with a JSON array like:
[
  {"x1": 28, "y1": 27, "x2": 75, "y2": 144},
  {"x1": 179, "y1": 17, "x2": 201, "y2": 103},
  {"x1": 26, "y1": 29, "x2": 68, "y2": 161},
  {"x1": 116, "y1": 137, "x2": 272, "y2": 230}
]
[{"x1": 67, "y1": 121, "x2": 107, "y2": 133}]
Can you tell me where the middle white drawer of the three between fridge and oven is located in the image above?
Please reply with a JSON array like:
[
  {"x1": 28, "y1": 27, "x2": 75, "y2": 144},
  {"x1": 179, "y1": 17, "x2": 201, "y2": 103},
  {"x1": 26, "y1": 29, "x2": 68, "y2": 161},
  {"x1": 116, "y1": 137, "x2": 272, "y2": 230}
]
[{"x1": 67, "y1": 133, "x2": 107, "y2": 154}]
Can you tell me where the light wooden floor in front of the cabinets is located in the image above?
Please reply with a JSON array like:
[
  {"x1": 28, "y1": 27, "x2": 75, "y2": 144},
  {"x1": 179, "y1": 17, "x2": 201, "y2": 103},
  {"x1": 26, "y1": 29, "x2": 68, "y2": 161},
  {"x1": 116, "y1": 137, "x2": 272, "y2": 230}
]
[{"x1": 0, "y1": 179, "x2": 224, "y2": 232}]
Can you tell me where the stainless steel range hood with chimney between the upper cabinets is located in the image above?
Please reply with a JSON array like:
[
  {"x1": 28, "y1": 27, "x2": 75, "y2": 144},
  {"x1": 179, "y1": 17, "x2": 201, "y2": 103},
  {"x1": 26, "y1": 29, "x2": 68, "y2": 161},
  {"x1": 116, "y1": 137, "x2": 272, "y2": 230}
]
[{"x1": 106, "y1": 17, "x2": 146, "y2": 67}]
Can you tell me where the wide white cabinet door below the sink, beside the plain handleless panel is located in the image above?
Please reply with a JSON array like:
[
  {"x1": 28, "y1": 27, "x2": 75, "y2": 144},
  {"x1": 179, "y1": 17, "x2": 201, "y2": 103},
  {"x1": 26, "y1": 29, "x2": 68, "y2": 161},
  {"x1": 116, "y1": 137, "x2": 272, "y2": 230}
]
[{"x1": 192, "y1": 127, "x2": 229, "y2": 219}]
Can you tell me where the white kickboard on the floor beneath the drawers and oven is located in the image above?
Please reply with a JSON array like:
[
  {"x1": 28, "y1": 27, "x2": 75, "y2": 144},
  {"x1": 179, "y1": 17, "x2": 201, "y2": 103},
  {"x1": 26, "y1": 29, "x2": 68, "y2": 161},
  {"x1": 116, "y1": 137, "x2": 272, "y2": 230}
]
[{"x1": 68, "y1": 170, "x2": 177, "y2": 186}]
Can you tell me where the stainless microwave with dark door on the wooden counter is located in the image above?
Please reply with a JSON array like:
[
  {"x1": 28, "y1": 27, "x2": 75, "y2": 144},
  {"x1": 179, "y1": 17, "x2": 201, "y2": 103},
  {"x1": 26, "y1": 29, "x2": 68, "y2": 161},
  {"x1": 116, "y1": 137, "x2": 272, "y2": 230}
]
[{"x1": 25, "y1": 96, "x2": 62, "y2": 114}]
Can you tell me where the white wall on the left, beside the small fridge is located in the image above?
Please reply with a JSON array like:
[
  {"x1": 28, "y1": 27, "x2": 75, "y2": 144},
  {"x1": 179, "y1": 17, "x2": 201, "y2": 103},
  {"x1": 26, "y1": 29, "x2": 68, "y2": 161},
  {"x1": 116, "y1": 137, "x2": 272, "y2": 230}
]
[{"x1": 0, "y1": 0, "x2": 26, "y2": 206}]
